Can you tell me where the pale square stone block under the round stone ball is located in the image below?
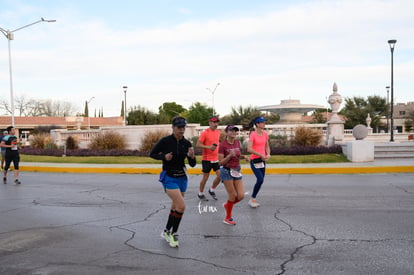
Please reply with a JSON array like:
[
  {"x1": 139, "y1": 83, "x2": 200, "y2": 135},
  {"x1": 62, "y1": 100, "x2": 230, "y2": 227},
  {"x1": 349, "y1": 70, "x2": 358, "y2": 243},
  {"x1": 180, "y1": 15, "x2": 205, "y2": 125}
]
[{"x1": 346, "y1": 140, "x2": 374, "y2": 162}]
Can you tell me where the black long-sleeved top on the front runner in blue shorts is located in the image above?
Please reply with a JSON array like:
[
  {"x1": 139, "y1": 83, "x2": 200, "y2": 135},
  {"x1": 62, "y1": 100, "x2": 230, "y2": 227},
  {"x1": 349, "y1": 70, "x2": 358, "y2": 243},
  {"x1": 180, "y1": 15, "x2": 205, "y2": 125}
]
[{"x1": 150, "y1": 135, "x2": 196, "y2": 175}]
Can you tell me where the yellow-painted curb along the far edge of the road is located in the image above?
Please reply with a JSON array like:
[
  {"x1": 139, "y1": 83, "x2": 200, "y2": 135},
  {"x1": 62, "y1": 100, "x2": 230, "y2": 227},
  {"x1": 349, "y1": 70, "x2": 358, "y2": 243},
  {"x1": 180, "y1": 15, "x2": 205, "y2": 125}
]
[{"x1": 20, "y1": 166, "x2": 414, "y2": 175}]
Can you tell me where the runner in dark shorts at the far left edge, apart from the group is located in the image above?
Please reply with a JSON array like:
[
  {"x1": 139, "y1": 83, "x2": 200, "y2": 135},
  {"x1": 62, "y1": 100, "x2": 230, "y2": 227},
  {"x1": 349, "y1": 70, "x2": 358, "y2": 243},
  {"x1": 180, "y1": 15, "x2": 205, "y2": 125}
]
[{"x1": 0, "y1": 126, "x2": 21, "y2": 184}]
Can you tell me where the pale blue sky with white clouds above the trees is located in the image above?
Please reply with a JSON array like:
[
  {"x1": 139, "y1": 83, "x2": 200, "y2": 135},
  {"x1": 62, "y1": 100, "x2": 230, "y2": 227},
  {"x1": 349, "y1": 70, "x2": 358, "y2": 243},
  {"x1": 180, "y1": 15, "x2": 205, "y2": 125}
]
[{"x1": 0, "y1": 0, "x2": 414, "y2": 116}]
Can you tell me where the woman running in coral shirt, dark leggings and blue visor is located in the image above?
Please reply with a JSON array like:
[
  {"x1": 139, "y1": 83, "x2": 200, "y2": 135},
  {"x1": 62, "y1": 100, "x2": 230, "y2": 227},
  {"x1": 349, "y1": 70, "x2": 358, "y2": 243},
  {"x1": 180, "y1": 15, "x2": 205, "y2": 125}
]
[{"x1": 247, "y1": 116, "x2": 270, "y2": 208}]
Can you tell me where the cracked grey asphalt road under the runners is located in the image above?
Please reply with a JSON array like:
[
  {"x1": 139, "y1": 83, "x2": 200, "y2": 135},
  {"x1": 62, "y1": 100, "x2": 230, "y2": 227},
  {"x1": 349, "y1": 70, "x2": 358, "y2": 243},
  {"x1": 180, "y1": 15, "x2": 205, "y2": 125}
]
[{"x1": 0, "y1": 172, "x2": 414, "y2": 275}]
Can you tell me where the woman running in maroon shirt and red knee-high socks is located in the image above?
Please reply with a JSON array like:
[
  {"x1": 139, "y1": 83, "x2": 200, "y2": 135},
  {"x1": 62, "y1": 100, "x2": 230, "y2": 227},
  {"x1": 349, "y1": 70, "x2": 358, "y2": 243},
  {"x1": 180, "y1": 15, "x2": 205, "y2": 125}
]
[{"x1": 219, "y1": 125, "x2": 249, "y2": 225}]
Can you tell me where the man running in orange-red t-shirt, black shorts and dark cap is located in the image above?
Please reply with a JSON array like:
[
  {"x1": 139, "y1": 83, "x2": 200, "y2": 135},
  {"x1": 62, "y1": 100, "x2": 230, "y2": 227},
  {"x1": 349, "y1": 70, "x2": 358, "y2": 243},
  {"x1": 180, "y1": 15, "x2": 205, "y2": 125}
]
[{"x1": 196, "y1": 116, "x2": 220, "y2": 201}]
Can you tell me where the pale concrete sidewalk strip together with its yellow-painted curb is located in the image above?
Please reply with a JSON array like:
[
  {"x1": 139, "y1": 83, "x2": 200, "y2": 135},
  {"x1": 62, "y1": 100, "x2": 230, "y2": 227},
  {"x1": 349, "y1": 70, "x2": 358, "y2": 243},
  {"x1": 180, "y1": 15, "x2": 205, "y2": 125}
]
[{"x1": 20, "y1": 158, "x2": 414, "y2": 175}]
